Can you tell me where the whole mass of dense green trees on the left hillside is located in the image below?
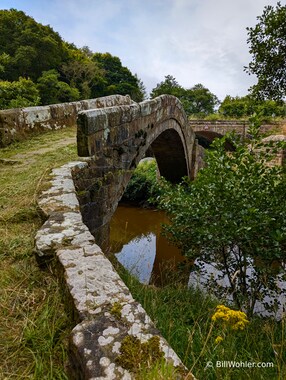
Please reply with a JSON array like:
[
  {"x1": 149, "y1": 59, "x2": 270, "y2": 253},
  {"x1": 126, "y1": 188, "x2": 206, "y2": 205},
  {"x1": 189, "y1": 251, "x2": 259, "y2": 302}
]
[{"x1": 0, "y1": 9, "x2": 145, "y2": 108}]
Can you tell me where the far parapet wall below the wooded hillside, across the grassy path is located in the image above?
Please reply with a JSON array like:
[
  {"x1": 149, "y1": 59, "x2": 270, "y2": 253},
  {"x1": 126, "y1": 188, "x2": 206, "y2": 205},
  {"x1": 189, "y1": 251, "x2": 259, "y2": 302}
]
[{"x1": 0, "y1": 95, "x2": 133, "y2": 148}]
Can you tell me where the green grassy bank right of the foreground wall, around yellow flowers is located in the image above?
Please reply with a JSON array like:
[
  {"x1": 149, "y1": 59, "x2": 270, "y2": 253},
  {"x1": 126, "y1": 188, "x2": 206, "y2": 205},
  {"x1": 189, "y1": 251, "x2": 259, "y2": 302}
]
[{"x1": 118, "y1": 268, "x2": 286, "y2": 380}]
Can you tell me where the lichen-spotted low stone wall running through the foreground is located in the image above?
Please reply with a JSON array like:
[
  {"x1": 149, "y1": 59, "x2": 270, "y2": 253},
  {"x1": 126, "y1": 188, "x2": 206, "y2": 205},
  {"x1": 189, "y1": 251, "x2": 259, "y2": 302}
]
[{"x1": 35, "y1": 162, "x2": 193, "y2": 380}]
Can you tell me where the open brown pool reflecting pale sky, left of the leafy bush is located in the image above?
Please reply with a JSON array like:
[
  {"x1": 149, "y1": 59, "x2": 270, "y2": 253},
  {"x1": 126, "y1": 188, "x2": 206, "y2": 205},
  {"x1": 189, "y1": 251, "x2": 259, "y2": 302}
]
[{"x1": 110, "y1": 205, "x2": 184, "y2": 284}]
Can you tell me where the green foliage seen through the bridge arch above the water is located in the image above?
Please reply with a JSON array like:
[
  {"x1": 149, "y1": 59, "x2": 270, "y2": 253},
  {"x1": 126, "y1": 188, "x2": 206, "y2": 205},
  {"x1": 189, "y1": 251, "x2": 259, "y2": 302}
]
[{"x1": 123, "y1": 160, "x2": 157, "y2": 202}]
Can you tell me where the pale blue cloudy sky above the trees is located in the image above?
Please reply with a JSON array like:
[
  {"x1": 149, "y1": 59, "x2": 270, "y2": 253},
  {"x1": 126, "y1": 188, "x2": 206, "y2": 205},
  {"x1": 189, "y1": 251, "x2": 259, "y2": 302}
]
[{"x1": 0, "y1": 0, "x2": 284, "y2": 101}]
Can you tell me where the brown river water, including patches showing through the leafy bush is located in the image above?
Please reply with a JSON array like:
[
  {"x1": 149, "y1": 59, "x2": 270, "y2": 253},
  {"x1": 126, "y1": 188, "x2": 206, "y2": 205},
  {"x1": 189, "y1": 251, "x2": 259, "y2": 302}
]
[{"x1": 109, "y1": 204, "x2": 286, "y2": 319}]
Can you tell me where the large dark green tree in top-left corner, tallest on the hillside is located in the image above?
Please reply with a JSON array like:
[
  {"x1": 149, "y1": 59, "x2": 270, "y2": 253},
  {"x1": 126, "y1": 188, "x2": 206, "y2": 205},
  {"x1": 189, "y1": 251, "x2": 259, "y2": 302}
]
[{"x1": 0, "y1": 9, "x2": 67, "y2": 81}]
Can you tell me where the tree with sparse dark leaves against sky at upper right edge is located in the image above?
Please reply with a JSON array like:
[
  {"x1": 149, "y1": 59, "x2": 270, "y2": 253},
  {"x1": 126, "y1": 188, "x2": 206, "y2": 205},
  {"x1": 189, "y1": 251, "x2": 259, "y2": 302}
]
[{"x1": 245, "y1": 2, "x2": 286, "y2": 100}]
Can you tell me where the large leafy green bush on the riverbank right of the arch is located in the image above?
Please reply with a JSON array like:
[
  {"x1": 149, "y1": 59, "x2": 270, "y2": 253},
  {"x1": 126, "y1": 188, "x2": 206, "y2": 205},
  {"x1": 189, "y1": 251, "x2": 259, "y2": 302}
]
[{"x1": 156, "y1": 121, "x2": 286, "y2": 315}]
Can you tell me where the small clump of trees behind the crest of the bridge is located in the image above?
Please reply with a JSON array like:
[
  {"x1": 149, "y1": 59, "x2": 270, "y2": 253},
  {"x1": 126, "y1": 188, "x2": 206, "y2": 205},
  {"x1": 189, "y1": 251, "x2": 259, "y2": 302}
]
[{"x1": 150, "y1": 75, "x2": 219, "y2": 117}]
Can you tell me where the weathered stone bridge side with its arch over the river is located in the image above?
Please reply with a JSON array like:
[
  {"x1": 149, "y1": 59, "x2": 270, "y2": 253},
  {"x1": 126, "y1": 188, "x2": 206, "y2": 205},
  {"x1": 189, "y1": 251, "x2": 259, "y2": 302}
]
[{"x1": 74, "y1": 95, "x2": 200, "y2": 243}]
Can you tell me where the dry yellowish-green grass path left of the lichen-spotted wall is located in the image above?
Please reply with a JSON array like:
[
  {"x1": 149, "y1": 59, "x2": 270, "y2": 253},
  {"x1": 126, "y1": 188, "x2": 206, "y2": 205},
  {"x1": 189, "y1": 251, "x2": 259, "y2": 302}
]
[{"x1": 0, "y1": 128, "x2": 78, "y2": 380}]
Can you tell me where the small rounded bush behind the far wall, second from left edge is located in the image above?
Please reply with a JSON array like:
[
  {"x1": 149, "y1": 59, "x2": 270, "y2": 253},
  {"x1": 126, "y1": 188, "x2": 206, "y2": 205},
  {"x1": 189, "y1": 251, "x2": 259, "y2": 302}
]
[{"x1": 37, "y1": 70, "x2": 80, "y2": 104}]
